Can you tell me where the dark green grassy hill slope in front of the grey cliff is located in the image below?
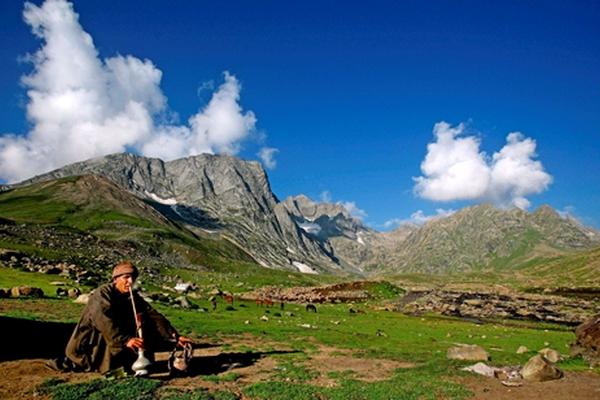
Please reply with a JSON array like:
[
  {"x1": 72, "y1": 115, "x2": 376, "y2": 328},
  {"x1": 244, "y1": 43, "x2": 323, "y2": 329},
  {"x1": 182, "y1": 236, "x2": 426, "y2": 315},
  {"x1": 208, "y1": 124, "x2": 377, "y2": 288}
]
[{"x1": 0, "y1": 175, "x2": 253, "y2": 274}]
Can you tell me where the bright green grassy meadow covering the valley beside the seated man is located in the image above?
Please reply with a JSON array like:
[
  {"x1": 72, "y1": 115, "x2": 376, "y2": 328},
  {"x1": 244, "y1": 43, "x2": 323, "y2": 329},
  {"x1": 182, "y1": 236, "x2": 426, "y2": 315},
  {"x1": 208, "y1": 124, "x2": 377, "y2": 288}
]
[{"x1": 0, "y1": 268, "x2": 588, "y2": 400}]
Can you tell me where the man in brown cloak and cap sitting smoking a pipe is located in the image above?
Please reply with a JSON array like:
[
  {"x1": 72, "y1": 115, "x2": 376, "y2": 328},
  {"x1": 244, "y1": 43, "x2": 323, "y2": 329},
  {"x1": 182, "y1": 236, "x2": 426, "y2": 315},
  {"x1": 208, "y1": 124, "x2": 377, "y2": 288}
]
[{"x1": 47, "y1": 261, "x2": 191, "y2": 373}]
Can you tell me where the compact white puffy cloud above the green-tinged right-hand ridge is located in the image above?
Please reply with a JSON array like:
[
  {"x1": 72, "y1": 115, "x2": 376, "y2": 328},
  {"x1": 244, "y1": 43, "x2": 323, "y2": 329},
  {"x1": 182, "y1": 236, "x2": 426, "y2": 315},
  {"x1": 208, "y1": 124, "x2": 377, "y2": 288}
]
[{"x1": 414, "y1": 122, "x2": 552, "y2": 209}]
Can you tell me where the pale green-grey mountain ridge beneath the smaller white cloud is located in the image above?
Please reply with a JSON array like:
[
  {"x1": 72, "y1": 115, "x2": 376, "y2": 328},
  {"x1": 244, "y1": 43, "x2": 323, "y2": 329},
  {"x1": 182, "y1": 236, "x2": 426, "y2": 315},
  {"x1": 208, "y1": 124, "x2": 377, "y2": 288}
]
[{"x1": 379, "y1": 204, "x2": 599, "y2": 273}]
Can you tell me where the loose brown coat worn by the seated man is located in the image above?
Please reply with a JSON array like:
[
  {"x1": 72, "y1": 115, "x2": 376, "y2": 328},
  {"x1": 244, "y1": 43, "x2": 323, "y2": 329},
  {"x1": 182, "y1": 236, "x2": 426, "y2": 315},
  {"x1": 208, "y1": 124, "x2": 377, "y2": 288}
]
[{"x1": 65, "y1": 283, "x2": 177, "y2": 373}]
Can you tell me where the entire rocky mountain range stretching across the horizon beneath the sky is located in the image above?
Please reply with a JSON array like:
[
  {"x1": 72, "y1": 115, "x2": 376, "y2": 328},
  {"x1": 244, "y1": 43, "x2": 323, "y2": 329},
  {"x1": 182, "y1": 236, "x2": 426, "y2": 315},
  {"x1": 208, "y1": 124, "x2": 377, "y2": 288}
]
[{"x1": 4, "y1": 154, "x2": 600, "y2": 274}]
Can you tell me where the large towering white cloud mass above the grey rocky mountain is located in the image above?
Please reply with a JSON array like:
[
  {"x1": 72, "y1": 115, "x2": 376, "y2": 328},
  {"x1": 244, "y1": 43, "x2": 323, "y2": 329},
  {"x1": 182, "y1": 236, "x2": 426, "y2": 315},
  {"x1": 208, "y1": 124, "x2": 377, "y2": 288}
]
[{"x1": 0, "y1": 0, "x2": 256, "y2": 182}]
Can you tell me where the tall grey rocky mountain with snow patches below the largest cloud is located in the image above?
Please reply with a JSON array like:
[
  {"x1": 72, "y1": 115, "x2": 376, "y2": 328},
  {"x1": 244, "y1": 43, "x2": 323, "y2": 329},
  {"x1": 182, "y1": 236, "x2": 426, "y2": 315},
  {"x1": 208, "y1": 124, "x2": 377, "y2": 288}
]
[{"x1": 7, "y1": 153, "x2": 344, "y2": 273}]
